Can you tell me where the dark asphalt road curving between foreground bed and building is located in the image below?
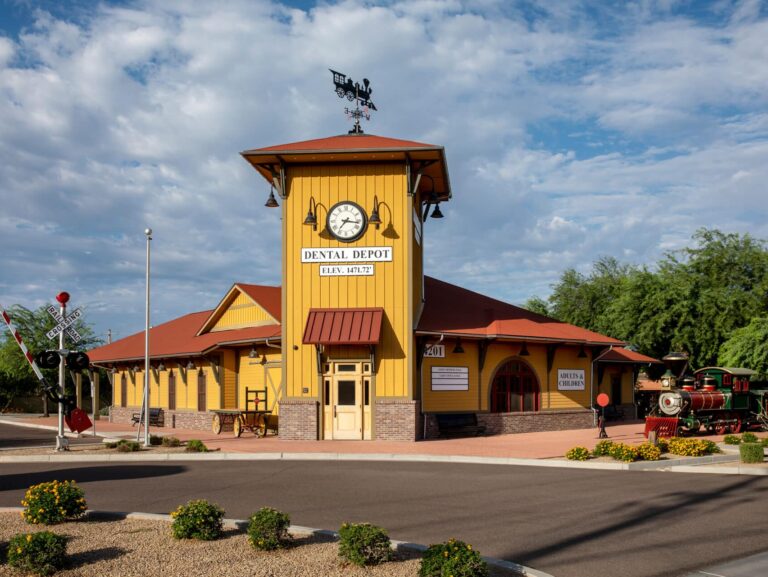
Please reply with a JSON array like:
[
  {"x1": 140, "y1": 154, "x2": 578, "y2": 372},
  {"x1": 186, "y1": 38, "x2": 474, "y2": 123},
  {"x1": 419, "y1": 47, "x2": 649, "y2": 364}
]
[{"x1": 0, "y1": 454, "x2": 768, "y2": 577}]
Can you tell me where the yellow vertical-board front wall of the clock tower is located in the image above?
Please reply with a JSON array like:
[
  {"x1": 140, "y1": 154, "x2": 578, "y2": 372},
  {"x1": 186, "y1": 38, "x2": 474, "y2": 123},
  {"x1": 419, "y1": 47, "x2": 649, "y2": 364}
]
[{"x1": 282, "y1": 164, "x2": 413, "y2": 399}]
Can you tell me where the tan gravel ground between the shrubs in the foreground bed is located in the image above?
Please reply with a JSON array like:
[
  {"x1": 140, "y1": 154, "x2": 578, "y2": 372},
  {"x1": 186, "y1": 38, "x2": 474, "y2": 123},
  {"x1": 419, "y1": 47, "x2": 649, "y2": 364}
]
[{"x1": 0, "y1": 513, "x2": 516, "y2": 577}]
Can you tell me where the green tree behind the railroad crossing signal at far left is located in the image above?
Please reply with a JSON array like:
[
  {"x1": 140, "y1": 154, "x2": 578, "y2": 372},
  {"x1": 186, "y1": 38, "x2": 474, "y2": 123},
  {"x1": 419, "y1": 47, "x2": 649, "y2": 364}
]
[{"x1": 0, "y1": 305, "x2": 101, "y2": 411}]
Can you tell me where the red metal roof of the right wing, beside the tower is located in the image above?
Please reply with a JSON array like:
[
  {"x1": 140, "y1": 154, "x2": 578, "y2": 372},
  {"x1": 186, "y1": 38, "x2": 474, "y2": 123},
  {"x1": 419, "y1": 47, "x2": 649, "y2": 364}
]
[{"x1": 416, "y1": 277, "x2": 624, "y2": 346}]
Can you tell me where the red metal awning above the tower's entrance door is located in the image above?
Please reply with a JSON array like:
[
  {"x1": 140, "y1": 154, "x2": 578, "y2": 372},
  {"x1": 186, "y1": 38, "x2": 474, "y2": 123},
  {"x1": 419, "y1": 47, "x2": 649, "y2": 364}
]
[{"x1": 302, "y1": 308, "x2": 384, "y2": 345}]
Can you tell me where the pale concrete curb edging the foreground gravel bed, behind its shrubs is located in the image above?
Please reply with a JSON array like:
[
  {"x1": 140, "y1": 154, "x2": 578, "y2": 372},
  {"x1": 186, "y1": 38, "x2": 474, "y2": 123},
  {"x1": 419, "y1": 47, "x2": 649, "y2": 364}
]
[{"x1": 0, "y1": 507, "x2": 553, "y2": 577}]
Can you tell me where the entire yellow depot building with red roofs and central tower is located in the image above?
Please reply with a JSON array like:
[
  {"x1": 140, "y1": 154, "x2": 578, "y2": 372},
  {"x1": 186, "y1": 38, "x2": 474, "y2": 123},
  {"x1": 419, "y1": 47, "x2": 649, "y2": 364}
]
[{"x1": 90, "y1": 134, "x2": 654, "y2": 440}]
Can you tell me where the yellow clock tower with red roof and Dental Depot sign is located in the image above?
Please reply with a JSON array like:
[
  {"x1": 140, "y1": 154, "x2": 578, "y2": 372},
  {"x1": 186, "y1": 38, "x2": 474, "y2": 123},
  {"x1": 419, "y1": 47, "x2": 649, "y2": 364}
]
[{"x1": 242, "y1": 133, "x2": 451, "y2": 440}]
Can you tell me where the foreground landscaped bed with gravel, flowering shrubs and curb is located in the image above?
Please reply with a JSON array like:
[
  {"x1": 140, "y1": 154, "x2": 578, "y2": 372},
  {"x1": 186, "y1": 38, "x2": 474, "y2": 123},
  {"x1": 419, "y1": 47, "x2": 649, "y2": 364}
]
[{"x1": 0, "y1": 481, "x2": 548, "y2": 577}]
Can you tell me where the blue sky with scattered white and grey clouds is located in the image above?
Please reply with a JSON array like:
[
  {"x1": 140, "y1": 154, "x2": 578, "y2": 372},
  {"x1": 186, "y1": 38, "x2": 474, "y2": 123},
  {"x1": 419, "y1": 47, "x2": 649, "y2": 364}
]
[{"x1": 0, "y1": 0, "x2": 768, "y2": 338}]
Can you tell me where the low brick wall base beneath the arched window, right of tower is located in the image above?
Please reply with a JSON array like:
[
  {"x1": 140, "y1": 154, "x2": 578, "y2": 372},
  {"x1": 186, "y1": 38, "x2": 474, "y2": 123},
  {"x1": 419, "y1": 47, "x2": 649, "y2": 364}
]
[{"x1": 426, "y1": 410, "x2": 595, "y2": 439}]
